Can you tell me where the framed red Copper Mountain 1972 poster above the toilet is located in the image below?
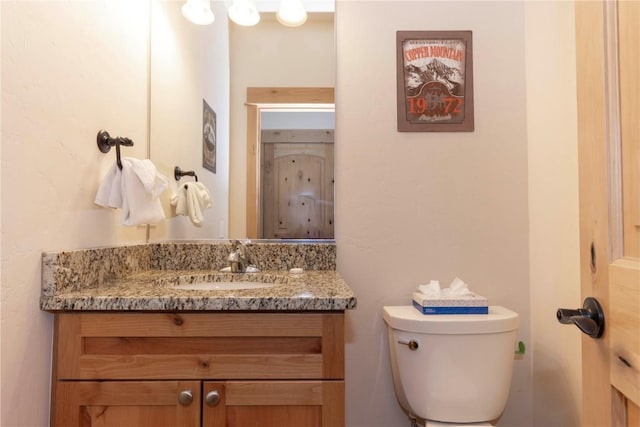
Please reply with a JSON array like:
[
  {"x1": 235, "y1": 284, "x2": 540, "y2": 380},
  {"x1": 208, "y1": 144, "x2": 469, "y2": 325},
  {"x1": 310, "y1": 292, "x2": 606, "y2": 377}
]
[{"x1": 396, "y1": 31, "x2": 473, "y2": 132}]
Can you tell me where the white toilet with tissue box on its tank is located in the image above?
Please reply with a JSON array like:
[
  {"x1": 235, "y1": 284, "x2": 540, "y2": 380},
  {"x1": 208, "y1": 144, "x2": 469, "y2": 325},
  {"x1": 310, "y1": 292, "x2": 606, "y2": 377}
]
[{"x1": 383, "y1": 305, "x2": 518, "y2": 427}]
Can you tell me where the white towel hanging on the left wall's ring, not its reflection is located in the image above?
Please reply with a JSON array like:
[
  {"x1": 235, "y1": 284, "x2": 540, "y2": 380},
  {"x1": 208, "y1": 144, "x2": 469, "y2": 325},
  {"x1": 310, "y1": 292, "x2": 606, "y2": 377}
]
[{"x1": 95, "y1": 157, "x2": 169, "y2": 225}]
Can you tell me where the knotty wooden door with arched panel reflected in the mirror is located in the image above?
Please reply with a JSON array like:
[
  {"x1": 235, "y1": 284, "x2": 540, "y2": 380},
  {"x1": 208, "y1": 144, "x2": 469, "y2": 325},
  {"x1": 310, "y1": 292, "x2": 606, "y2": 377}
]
[{"x1": 261, "y1": 130, "x2": 334, "y2": 239}]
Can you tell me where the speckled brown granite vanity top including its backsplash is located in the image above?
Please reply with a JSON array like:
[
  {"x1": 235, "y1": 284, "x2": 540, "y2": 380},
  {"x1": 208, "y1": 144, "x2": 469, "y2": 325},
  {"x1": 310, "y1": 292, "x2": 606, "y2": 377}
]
[{"x1": 40, "y1": 242, "x2": 356, "y2": 311}]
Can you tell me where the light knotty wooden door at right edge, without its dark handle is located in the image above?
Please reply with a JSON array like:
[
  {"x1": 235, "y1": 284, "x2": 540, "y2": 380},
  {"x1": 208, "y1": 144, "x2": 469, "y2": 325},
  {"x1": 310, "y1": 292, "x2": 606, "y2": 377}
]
[{"x1": 576, "y1": 1, "x2": 640, "y2": 427}]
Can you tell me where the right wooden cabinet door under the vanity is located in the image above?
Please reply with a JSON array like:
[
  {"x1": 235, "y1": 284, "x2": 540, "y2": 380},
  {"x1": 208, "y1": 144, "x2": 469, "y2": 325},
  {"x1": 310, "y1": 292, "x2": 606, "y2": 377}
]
[{"x1": 202, "y1": 381, "x2": 344, "y2": 427}]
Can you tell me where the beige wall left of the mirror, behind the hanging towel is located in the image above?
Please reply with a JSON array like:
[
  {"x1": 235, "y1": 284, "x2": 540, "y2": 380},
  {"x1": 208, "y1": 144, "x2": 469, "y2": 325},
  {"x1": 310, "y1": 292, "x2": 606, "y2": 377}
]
[{"x1": 0, "y1": 0, "x2": 149, "y2": 427}]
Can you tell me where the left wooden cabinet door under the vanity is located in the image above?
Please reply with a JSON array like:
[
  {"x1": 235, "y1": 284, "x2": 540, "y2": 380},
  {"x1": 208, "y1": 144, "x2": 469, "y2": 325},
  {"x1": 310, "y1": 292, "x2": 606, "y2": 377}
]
[{"x1": 52, "y1": 381, "x2": 201, "y2": 427}]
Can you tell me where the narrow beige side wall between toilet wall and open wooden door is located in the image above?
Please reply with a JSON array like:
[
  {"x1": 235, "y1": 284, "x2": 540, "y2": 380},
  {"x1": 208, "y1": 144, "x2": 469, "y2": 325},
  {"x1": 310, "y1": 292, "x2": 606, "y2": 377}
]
[{"x1": 525, "y1": 2, "x2": 582, "y2": 427}]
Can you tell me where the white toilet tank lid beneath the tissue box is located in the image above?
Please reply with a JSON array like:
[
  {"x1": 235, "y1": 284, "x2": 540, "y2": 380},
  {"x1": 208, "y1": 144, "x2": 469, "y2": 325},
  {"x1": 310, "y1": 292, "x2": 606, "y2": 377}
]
[{"x1": 382, "y1": 305, "x2": 519, "y2": 334}]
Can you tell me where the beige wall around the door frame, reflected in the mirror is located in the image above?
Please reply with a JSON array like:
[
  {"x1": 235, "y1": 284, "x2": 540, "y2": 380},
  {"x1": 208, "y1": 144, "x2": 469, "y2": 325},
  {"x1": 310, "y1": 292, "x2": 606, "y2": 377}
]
[{"x1": 229, "y1": 14, "x2": 335, "y2": 238}]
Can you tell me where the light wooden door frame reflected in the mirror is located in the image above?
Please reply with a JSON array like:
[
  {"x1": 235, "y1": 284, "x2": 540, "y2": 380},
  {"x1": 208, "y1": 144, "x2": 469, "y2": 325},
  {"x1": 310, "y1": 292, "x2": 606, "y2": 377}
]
[{"x1": 245, "y1": 87, "x2": 335, "y2": 239}]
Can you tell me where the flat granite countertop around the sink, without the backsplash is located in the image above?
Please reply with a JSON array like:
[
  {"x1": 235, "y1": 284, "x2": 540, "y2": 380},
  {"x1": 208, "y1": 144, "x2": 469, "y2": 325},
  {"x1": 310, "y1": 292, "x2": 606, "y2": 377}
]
[{"x1": 41, "y1": 270, "x2": 356, "y2": 311}]
